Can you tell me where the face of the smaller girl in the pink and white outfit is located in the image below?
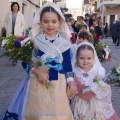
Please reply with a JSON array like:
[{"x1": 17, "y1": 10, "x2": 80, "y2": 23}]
[{"x1": 77, "y1": 50, "x2": 94, "y2": 72}]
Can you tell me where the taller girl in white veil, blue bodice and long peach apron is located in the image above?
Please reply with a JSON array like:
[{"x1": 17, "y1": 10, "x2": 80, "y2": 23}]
[{"x1": 4, "y1": 3, "x2": 76, "y2": 120}]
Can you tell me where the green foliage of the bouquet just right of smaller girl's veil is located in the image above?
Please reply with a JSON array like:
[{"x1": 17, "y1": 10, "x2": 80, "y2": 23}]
[{"x1": 95, "y1": 42, "x2": 105, "y2": 62}]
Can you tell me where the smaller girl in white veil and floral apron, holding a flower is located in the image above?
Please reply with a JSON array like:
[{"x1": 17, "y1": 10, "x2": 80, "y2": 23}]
[{"x1": 71, "y1": 42, "x2": 119, "y2": 120}]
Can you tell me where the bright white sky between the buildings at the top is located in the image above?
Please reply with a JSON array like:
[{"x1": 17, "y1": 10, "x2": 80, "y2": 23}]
[{"x1": 66, "y1": 0, "x2": 82, "y2": 8}]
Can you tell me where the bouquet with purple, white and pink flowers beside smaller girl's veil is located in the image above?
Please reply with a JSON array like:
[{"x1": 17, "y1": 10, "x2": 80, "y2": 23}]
[{"x1": 95, "y1": 42, "x2": 112, "y2": 62}]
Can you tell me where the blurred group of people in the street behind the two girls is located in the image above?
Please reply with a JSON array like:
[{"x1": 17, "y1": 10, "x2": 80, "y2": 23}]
[{"x1": 66, "y1": 14, "x2": 102, "y2": 45}]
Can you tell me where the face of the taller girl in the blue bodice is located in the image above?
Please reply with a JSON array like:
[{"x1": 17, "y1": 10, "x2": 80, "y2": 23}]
[{"x1": 40, "y1": 12, "x2": 60, "y2": 38}]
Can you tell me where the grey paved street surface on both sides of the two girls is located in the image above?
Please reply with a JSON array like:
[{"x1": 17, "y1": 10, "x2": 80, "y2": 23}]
[{"x1": 0, "y1": 38, "x2": 120, "y2": 120}]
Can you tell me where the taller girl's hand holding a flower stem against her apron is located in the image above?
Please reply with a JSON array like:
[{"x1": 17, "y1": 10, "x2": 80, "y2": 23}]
[{"x1": 31, "y1": 67, "x2": 49, "y2": 84}]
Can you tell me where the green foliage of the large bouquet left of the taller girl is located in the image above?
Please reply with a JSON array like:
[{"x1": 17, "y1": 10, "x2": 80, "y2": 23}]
[{"x1": 0, "y1": 34, "x2": 33, "y2": 62}]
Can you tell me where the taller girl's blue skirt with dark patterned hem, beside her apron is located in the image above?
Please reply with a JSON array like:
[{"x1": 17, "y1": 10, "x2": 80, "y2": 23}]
[{"x1": 3, "y1": 76, "x2": 30, "y2": 120}]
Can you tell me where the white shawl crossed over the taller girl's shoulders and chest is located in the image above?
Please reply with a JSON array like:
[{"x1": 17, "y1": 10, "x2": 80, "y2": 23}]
[{"x1": 34, "y1": 34, "x2": 71, "y2": 63}]
